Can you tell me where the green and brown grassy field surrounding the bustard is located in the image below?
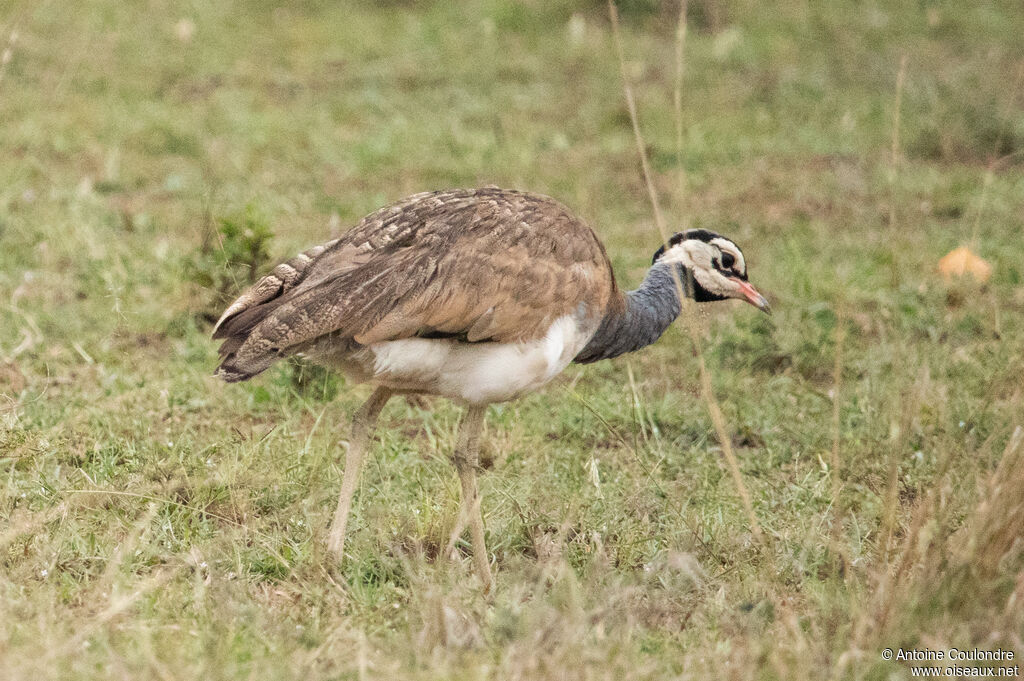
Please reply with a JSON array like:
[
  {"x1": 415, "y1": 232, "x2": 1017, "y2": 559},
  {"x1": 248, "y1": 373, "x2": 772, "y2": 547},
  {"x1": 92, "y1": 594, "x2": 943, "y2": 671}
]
[{"x1": 0, "y1": 0, "x2": 1024, "y2": 681}]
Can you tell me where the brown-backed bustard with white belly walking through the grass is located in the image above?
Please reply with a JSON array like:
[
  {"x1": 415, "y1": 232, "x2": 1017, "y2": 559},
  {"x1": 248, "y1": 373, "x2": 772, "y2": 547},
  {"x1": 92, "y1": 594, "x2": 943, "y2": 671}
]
[{"x1": 213, "y1": 186, "x2": 770, "y2": 592}]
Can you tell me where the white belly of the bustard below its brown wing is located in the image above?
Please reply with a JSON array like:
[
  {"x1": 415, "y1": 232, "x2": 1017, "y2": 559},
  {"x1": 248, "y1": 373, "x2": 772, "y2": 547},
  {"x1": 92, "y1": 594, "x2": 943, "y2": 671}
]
[{"x1": 352, "y1": 316, "x2": 594, "y2": 403}]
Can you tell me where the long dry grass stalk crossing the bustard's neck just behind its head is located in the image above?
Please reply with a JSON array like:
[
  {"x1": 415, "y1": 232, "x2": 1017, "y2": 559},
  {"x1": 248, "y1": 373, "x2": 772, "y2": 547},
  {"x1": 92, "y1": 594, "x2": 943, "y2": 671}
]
[{"x1": 608, "y1": 0, "x2": 763, "y2": 543}]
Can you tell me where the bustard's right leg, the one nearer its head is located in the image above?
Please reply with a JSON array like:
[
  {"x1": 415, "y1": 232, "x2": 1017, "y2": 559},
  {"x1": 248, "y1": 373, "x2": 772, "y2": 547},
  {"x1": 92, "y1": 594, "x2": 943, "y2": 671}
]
[{"x1": 445, "y1": 405, "x2": 490, "y2": 592}]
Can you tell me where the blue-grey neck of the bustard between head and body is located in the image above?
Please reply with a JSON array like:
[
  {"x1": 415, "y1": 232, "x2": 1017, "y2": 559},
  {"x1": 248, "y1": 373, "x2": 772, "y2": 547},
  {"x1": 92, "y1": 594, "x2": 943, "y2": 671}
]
[{"x1": 574, "y1": 262, "x2": 686, "y2": 364}]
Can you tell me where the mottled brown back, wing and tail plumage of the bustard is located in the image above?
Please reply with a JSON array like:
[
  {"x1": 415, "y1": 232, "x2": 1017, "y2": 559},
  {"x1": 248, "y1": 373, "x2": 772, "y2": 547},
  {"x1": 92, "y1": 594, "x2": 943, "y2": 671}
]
[{"x1": 214, "y1": 187, "x2": 622, "y2": 381}]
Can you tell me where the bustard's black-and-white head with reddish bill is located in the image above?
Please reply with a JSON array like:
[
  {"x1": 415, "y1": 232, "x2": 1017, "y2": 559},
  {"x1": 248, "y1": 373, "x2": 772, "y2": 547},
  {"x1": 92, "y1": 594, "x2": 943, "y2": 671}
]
[{"x1": 651, "y1": 229, "x2": 771, "y2": 313}]
